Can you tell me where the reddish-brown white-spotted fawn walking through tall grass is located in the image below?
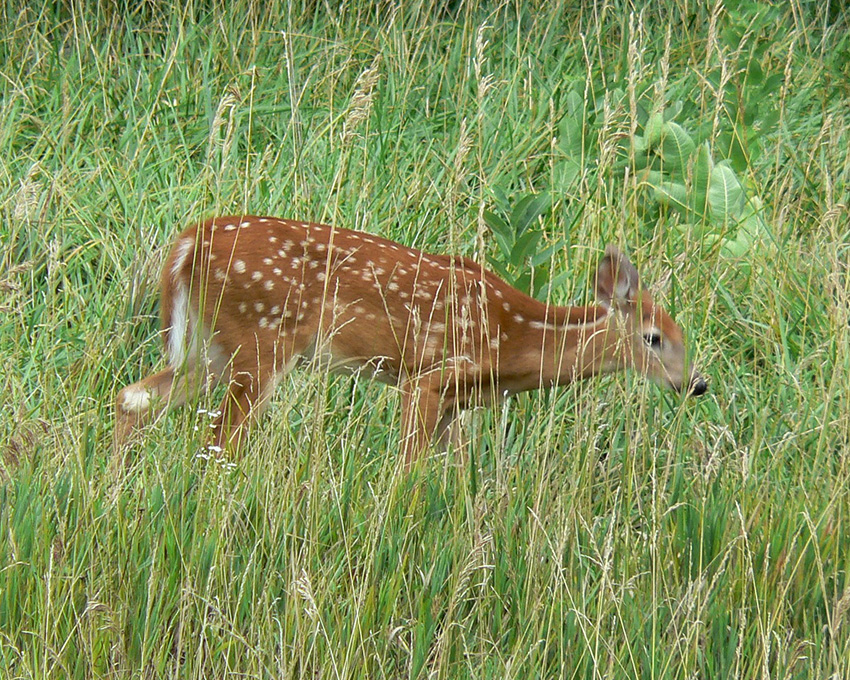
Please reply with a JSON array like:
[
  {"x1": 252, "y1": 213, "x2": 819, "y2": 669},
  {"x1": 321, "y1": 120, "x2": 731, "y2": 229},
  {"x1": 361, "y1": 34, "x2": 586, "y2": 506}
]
[{"x1": 115, "y1": 216, "x2": 706, "y2": 465}]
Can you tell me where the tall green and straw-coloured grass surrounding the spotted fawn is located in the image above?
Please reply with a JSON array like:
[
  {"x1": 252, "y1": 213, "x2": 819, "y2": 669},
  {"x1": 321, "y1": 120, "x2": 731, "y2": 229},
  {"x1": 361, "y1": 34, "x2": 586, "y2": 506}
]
[{"x1": 0, "y1": 0, "x2": 850, "y2": 679}]
